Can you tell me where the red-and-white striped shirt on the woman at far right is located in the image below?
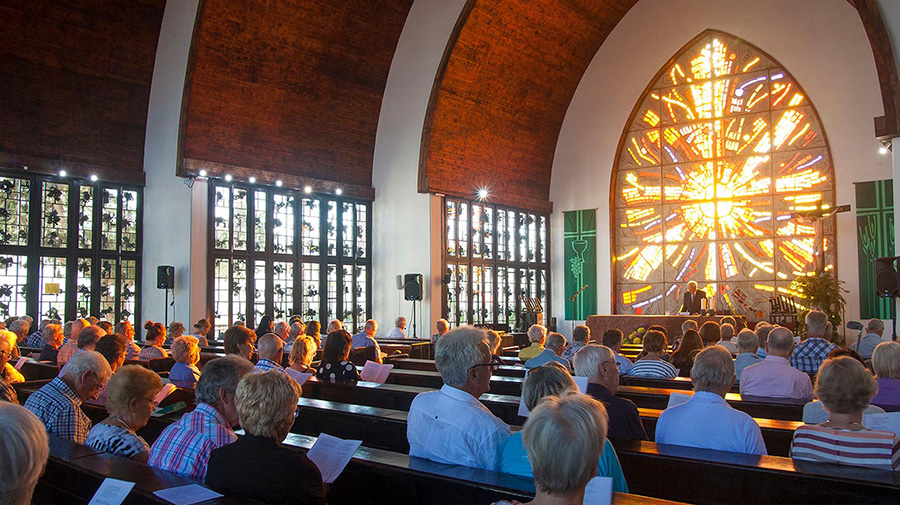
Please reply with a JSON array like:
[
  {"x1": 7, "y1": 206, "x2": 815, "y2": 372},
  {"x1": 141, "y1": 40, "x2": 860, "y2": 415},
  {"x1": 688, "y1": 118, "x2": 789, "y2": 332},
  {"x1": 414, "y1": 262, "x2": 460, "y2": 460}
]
[{"x1": 791, "y1": 424, "x2": 900, "y2": 470}]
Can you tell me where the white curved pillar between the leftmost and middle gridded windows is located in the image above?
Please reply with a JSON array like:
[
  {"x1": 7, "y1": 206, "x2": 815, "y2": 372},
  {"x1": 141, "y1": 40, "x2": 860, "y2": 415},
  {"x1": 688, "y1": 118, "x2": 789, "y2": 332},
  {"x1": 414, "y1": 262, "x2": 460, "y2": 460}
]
[{"x1": 142, "y1": 0, "x2": 200, "y2": 327}]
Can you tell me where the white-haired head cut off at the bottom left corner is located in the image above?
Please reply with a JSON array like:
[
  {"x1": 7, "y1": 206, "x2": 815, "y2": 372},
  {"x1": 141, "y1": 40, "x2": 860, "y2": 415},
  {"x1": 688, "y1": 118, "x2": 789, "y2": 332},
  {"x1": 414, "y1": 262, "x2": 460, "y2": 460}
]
[{"x1": 0, "y1": 403, "x2": 50, "y2": 505}]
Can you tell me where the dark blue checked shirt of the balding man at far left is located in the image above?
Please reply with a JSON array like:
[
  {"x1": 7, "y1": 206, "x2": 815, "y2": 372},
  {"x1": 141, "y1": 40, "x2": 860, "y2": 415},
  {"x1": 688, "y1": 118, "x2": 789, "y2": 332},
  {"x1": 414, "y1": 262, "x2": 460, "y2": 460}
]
[{"x1": 25, "y1": 377, "x2": 91, "y2": 444}]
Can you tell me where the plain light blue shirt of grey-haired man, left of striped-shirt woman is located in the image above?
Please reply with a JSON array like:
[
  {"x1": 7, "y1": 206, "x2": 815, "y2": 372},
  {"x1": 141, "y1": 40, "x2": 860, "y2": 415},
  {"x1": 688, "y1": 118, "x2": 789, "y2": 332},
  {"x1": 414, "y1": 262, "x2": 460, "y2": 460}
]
[{"x1": 656, "y1": 391, "x2": 766, "y2": 455}]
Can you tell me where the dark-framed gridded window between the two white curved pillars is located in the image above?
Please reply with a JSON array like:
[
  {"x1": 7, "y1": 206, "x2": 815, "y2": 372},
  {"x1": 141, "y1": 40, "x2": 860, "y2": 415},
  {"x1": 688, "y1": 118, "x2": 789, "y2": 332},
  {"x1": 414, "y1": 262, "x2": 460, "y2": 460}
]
[{"x1": 209, "y1": 181, "x2": 372, "y2": 335}]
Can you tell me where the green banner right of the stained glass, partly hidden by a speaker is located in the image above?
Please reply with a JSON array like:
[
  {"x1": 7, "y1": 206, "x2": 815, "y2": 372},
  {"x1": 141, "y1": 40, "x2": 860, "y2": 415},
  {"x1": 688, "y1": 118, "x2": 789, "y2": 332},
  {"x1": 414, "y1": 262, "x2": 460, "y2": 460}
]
[{"x1": 856, "y1": 179, "x2": 894, "y2": 319}]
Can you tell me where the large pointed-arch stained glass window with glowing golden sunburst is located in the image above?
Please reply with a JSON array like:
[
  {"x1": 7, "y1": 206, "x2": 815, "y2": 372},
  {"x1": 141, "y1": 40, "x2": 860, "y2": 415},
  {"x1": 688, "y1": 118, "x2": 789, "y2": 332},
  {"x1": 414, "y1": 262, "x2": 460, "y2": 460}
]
[{"x1": 612, "y1": 31, "x2": 835, "y2": 314}]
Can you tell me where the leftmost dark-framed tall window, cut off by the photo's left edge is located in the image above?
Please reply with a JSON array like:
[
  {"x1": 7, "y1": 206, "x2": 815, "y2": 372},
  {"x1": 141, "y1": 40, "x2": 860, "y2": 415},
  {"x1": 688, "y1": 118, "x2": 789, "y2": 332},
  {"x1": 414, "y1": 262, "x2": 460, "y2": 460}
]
[{"x1": 0, "y1": 174, "x2": 142, "y2": 323}]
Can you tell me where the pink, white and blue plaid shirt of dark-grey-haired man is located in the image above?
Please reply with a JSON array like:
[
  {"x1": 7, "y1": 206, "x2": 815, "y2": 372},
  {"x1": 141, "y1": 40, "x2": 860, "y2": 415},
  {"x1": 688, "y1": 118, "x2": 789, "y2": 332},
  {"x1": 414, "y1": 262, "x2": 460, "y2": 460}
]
[{"x1": 148, "y1": 403, "x2": 237, "y2": 482}]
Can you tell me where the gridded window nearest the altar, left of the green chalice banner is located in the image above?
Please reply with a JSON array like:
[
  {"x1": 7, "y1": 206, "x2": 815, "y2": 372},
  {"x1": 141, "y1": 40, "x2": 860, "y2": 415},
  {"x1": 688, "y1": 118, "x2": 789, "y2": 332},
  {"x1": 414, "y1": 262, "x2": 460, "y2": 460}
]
[{"x1": 443, "y1": 198, "x2": 550, "y2": 328}]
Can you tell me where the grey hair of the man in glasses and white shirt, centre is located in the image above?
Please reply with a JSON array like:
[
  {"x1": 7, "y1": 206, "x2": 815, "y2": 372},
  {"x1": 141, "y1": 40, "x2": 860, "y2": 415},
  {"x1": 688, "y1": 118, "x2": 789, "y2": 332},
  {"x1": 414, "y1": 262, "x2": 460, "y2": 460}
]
[{"x1": 434, "y1": 326, "x2": 490, "y2": 388}]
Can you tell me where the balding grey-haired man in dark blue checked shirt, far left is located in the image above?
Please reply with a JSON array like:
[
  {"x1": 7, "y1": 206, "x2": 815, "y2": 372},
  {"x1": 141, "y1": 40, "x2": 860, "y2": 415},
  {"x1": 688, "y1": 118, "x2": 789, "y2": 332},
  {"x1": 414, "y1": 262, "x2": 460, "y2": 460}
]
[{"x1": 25, "y1": 351, "x2": 112, "y2": 444}]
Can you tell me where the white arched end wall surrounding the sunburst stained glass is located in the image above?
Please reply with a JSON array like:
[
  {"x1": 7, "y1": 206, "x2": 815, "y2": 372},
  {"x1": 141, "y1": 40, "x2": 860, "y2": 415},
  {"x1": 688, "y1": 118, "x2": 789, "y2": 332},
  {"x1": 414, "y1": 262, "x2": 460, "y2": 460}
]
[{"x1": 550, "y1": 0, "x2": 892, "y2": 338}]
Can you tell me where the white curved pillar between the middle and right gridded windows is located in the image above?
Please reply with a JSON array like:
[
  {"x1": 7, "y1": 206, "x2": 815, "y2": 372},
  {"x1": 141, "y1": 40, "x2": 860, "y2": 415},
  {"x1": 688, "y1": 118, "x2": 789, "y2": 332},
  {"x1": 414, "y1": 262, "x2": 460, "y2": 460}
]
[{"x1": 372, "y1": 0, "x2": 466, "y2": 337}]
